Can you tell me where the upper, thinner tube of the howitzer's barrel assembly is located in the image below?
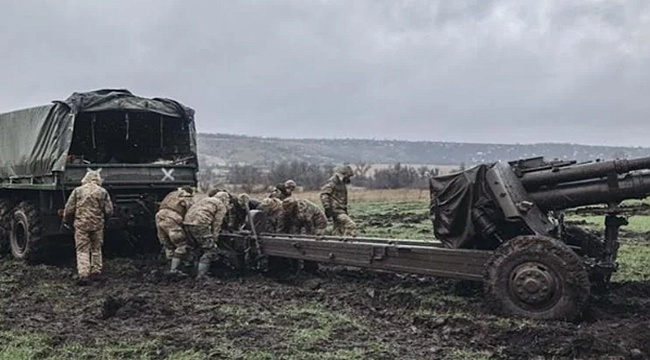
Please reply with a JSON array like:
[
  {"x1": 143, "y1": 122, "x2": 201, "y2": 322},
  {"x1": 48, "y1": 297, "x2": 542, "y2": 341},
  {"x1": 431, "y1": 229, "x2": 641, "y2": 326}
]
[{"x1": 521, "y1": 157, "x2": 650, "y2": 191}]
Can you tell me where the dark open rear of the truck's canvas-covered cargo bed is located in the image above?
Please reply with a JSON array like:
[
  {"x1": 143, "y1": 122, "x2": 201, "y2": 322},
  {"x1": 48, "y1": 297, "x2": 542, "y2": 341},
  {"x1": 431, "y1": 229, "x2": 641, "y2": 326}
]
[{"x1": 68, "y1": 111, "x2": 193, "y2": 164}]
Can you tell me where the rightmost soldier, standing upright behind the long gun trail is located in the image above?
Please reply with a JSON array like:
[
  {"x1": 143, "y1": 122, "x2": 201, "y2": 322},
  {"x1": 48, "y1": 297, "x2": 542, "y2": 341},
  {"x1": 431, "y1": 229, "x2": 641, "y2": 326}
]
[{"x1": 320, "y1": 165, "x2": 355, "y2": 236}]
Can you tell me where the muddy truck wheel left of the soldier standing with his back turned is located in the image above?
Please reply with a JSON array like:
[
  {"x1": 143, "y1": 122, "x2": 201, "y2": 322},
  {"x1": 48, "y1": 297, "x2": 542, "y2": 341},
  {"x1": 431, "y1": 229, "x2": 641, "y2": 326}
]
[{"x1": 9, "y1": 201, "x2": 42, "y2": 261}]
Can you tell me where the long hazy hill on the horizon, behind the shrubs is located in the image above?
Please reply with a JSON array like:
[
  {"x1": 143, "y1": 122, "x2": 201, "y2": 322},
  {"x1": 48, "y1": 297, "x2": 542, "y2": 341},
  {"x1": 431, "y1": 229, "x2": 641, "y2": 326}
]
[{"x1": 198, "y1": 134, "x2": 650, "y2": 166}]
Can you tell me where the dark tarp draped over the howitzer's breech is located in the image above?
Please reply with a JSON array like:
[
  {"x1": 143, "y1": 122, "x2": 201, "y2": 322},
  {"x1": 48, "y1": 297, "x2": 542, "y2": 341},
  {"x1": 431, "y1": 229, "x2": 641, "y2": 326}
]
[{"x1": 429, "y1": 164, "x2": 494, "y2": 249}]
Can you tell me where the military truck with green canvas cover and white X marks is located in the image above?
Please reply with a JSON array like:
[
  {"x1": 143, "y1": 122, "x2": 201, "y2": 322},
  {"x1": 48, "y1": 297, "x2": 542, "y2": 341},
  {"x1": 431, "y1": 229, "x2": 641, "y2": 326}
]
[{"x1": 0, "y1": 89, "x2": 198, "y2": 261}]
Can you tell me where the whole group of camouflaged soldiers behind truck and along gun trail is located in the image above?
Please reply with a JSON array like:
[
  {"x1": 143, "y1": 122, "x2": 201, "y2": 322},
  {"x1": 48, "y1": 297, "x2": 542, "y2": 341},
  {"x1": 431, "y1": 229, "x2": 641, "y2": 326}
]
[{"x1": 64, "y1": 166, "x2": 355, "y2": 281}]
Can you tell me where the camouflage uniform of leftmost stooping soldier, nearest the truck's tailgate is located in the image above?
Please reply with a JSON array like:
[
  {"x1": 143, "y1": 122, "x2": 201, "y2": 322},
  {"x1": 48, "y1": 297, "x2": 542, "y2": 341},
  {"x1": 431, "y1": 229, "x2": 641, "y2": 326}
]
[{"x1": 156, "y1": 188, "x2": 193, "y2": 260}]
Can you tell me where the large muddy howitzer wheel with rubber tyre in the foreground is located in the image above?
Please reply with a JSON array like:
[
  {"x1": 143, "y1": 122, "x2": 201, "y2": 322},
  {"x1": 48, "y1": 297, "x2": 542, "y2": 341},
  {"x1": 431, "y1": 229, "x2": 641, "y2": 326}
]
[{"x1": 485, "y1": 236, "x2": 590, "y2": 321}]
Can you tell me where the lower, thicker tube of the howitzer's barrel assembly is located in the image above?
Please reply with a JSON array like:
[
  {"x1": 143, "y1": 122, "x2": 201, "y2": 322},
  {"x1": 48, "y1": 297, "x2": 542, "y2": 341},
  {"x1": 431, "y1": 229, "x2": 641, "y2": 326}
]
[{"x1": 529, "y1": 174, "x2": 650, "y2": 211}]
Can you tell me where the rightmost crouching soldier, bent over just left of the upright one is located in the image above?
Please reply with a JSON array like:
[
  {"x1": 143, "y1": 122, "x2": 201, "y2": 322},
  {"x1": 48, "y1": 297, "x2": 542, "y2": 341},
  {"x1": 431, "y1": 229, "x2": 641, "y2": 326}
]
[{"x1": 282, "y1": 198, "x2": 327, "y2": 236}]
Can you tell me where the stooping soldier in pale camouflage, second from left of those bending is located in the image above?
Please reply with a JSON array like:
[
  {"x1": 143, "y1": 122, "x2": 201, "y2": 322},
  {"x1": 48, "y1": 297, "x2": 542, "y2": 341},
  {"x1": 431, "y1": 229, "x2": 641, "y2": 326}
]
[{"x1": 181, "y1": 190, "x2": 230, "y2": 278}]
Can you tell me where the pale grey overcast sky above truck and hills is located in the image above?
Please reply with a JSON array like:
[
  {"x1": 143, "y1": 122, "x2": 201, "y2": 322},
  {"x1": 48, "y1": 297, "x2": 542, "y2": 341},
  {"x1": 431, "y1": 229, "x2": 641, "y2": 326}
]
[{"x1": 0, "y1": 0, "x2": 650, "y2": 147}]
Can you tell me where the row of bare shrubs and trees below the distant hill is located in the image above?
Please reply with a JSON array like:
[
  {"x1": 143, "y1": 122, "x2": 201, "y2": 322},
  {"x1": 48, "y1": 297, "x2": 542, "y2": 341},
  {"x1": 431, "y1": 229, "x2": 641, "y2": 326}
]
[{"x1": 199, "y1": 160, "x2": 440, "y2": 192}]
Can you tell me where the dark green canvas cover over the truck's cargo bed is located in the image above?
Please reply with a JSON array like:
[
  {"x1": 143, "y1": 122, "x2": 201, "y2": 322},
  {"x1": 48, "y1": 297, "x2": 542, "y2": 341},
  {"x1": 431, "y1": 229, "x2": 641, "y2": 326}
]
[{"x1": 0, "y1": 89, "x2": 196, "y2": 179}]
